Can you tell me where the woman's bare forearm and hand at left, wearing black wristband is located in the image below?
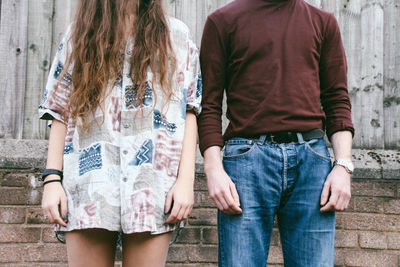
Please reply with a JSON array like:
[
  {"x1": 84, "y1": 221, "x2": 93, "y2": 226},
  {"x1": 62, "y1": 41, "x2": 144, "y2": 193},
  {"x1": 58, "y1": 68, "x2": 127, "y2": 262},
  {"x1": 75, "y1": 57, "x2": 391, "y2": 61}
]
[{"x1": 42, "y1": 120, "x2": 67, "y2": 226}]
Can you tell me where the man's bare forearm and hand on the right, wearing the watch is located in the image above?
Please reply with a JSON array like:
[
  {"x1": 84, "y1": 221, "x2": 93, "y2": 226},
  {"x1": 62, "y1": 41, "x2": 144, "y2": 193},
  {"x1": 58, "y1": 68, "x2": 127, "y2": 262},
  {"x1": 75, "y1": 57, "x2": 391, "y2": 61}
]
[{"x1": 321, "y1": 131, "x2": 353, "y2": 211}]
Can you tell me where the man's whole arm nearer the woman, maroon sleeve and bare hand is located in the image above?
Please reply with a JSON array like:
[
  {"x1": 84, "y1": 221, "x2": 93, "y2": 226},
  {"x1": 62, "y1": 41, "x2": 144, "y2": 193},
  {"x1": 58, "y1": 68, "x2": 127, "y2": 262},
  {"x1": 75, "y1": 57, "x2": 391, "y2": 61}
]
[{"x1": 198, "y1": 17, "x2": 242, "y2": 214}]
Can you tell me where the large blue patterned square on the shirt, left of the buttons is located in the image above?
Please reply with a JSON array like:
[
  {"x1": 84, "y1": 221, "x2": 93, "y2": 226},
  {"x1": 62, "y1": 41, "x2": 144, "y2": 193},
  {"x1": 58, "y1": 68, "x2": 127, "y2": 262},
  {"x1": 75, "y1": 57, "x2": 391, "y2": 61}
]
[{"x1": 79, "y1": 143, "x2": 103, "y2": 176}]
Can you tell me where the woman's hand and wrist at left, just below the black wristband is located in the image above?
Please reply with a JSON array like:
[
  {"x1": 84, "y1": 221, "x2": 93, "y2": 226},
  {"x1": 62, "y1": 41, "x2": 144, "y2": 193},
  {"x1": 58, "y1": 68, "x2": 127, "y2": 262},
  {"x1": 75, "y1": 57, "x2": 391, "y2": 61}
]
[{"x1": 42, "y1": 175, "x2": 68, "y2": 226}]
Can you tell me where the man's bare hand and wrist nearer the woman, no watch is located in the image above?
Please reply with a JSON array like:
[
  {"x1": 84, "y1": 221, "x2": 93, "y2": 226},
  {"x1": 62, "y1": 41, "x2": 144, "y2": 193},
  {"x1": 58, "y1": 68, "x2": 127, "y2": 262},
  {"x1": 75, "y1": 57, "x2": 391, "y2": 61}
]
[{"x1": 204, "y1": 147, "x2": 242, "y2": 215}]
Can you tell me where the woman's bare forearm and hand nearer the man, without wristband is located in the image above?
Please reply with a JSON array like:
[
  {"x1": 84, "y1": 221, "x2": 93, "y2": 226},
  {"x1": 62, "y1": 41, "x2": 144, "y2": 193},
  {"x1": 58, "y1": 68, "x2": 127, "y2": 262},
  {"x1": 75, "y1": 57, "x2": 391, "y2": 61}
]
[{"x1": 164, "y1": 111, "x2": 197, "y2": 223}]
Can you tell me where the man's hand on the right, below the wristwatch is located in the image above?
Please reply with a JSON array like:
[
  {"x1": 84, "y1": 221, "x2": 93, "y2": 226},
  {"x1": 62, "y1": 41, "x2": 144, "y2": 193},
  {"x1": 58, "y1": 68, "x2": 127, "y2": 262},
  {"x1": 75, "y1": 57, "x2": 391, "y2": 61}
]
[{"x1": 320, "y1": 165, "x2": 351, "y2": 212}]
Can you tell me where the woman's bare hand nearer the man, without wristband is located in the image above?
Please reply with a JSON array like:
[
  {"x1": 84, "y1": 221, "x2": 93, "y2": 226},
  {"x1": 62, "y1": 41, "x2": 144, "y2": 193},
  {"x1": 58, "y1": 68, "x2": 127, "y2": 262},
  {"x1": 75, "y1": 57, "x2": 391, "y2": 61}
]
[{"x1": 164, "y1": 177, "x2": 194, "y2": 223}]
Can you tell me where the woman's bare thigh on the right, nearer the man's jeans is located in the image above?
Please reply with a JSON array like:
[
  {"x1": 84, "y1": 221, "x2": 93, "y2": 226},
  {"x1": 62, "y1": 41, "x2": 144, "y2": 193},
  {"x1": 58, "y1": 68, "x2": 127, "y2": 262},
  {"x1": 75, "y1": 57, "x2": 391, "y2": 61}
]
[{"x1": 122, "y1": 232, "x2": 172, "y2": 267}]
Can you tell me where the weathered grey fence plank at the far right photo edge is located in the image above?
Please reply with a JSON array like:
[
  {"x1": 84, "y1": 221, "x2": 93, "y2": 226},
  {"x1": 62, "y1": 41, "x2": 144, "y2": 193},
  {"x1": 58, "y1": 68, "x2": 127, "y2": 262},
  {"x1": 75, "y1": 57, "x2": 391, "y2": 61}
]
[{"x1": 383, "y1": 0, "x2": 400, "y2": 148}]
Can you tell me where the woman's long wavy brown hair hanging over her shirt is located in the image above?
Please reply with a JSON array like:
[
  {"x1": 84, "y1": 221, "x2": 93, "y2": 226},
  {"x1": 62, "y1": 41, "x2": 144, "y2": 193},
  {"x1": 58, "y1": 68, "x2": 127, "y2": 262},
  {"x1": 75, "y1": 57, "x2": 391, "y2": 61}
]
[{"x1": 60, "y1": 0, "x2": 176, "y2": 129}]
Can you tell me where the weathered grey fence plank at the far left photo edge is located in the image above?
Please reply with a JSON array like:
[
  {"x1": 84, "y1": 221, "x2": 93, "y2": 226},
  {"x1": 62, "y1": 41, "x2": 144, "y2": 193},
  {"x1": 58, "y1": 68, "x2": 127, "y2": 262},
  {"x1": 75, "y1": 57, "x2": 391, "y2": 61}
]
[{"x1": 0, "y1": 0, "x2": 28, "y2": 139}]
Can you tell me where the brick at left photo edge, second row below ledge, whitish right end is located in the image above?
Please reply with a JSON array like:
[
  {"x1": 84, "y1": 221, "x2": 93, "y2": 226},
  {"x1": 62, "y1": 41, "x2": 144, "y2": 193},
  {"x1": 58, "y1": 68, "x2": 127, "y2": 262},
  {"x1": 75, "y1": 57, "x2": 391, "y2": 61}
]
[{"x1": 0, "y1": 187, "x2": 42, "y2": 205}]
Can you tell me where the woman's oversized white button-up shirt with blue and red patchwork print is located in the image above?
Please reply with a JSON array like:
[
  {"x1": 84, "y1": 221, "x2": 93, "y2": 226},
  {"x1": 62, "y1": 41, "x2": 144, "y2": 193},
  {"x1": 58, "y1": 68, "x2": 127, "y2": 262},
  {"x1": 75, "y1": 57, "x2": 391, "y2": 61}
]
[{"x1": 39, "y1": 18, "x2": 202, "y2": 237}]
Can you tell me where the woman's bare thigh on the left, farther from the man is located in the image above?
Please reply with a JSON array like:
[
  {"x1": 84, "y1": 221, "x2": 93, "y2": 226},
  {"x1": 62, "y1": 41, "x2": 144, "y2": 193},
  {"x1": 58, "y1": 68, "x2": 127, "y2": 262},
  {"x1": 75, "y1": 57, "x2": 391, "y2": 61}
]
[{"x1": 65, "y1": 229, "x2": 118, "y2": 267}]
